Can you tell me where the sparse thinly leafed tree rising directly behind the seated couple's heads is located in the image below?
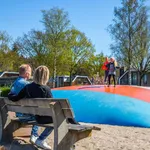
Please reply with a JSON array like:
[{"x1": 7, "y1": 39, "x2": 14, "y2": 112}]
[{"x1": 16, "y1": 30, "x2": 50, "y2": 68}]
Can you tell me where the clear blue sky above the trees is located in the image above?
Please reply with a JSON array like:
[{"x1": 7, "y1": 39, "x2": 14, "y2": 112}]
[{"x1": 0, "y1": 0, "x2": 150, "y2": 55}]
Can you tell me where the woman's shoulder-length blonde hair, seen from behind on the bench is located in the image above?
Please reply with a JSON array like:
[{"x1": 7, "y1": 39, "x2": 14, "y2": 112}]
[{"x1": 33, "y1": 66, "x2": 49, "y2": 85}]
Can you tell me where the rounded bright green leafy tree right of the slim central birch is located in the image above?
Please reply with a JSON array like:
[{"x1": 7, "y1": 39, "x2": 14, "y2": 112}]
[{"x1": 66, "y1": 29, "x2": 95, "y2": 85}]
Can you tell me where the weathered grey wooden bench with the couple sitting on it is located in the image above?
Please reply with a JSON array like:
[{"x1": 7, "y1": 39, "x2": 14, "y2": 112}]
[{"x1": 0, "y1": 97, "x2": 100, "y2": 150}]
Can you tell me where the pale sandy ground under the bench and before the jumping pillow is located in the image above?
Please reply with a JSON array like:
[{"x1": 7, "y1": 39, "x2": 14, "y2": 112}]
[{"x1": 1, "y1": 124, "x2": 150, "y2": 150}]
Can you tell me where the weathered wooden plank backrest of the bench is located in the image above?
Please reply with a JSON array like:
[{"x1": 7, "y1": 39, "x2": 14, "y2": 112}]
[{"x1": 1, "y1": 98, "x2": 74, "y2": 118}]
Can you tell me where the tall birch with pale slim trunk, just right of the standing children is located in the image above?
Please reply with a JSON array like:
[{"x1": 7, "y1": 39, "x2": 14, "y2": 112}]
[{"x1": 109, "y1": 0, "x2": 148, "y2": 85}]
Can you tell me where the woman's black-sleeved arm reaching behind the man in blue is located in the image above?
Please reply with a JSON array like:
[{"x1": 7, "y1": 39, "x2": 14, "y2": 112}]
[{"x1": 8, "y1": 87, "x2": 26, "y2": 102}]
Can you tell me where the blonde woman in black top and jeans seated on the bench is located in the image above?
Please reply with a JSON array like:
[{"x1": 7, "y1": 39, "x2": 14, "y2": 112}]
[{"x1": 8, "y1": 66, "x2": 53, "y2": 150}]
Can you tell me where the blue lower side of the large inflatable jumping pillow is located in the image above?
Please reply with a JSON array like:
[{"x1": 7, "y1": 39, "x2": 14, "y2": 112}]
[{"x1": 52, "y1": 90, "x2": 150, "y2": 127}]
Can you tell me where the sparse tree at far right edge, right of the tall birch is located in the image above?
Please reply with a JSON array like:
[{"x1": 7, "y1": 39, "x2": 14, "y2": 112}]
[{"x1": 132, "y1": 19, "x2": 150, "y2": 85}]
